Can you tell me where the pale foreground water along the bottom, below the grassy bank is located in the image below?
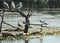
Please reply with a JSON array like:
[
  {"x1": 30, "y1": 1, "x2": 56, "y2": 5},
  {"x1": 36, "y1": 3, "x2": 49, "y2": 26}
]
[{"x1": 0, "y1": 36, "x2": 60, "y2": 43}]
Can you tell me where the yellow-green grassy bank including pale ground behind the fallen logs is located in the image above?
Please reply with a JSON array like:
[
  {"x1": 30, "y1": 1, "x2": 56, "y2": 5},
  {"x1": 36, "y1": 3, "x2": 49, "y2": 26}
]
[{"x1": 0, "y1": 27, "x2": 60, "y2": 40}]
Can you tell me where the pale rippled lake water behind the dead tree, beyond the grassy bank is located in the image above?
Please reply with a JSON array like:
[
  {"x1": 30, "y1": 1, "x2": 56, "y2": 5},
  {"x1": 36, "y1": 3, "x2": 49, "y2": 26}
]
[{"x1": 0, "y1": 11, "x2": 60, "y2": 29}]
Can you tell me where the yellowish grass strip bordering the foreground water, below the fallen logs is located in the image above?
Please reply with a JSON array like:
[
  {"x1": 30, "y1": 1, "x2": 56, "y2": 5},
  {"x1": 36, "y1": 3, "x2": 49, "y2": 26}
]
[{"x1": 0, "y1": 31, "x2": 60, "y2": 40}]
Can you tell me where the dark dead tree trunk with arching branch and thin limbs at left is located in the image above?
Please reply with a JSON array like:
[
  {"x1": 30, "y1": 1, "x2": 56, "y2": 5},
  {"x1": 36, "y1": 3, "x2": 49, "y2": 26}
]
[{"x1": 0, "y1": 9, "x2": 31, "y2": 33}]
